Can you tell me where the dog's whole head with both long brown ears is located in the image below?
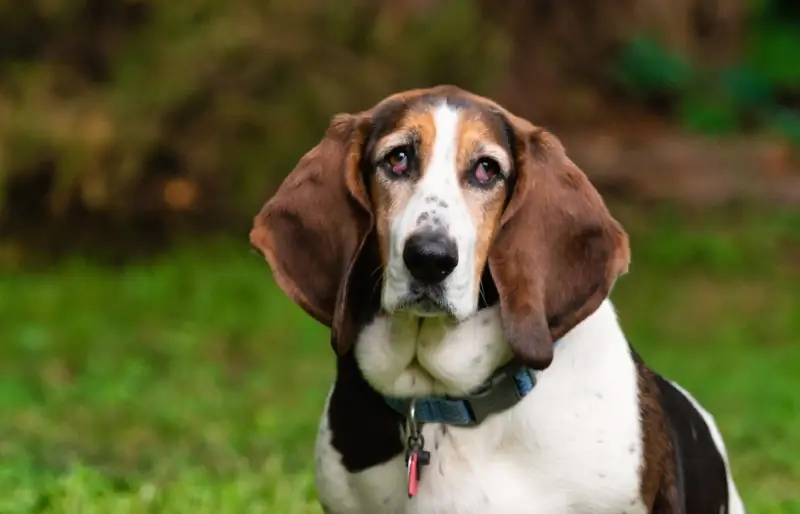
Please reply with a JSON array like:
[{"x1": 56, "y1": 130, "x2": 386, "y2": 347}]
[{"x1": 250, "y1": 86, "x2": 629, "y2": 369}]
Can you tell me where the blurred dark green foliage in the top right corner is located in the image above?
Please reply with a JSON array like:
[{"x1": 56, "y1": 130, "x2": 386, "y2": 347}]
[{"x1": 616, "y1": 0, "x2": 800, "y2": 145}]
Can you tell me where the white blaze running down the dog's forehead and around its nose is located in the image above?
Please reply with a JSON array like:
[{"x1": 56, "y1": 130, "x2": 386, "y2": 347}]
[{"x1": 382, "y1": 103, "x2": 478, "y2": 320}]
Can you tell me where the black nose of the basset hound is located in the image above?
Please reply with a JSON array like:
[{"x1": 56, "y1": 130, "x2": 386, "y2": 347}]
[{"x1": 403, "y1": 231, "x2": 458, "y2": 284}]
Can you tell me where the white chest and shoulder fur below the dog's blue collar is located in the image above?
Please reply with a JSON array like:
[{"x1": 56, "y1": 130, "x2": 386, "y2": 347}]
[{"x1": 316, "y1": 302, "x2": 645, "y2": 514}]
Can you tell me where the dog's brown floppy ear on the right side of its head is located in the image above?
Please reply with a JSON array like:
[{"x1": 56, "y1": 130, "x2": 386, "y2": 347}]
[{"x1": 489, "y1": 114, "x2": 630, "y2": 369}]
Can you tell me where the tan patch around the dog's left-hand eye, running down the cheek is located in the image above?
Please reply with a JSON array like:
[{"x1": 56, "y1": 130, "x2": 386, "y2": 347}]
[{"x1": 370, "y1": 109, "x2": 436, "y2": 269}]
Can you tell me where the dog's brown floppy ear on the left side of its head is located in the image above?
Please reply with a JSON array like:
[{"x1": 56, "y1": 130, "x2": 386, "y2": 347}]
[{"x1": 250, "y1": 113, "x2": 373, "y2": 353}]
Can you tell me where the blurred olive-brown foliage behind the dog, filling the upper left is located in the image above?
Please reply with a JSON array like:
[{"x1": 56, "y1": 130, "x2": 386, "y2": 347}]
[{"x1": 0, "y1": 0, "x2": 505, "y2": 226}]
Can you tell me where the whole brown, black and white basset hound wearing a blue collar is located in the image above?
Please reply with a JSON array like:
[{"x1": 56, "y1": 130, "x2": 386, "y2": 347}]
[{"x1": 250, "y1": 86, "x2": 745, "y2": 514}]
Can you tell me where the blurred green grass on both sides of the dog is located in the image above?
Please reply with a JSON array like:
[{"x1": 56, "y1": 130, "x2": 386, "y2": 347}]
[{"x1": 0, "y1": 209, "x2": 800, "y2": 514}]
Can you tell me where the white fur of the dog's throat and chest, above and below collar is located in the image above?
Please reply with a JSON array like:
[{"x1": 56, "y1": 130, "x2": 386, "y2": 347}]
[{"x1": 317, "y1": 301, "x2": 645, "y2": 514}]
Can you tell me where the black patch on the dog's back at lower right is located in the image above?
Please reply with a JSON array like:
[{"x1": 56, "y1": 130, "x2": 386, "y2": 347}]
[{"x1": 654, "y1": 374, "x2": 729, "y2": 514}]
